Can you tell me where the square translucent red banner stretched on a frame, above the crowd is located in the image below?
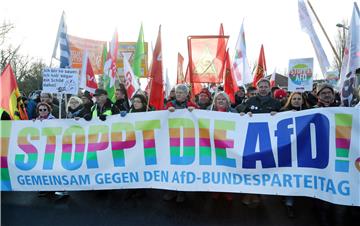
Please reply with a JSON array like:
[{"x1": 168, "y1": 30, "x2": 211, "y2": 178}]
[{"x1": 188, "y1": 36, "x2": 229, "y2": 83}]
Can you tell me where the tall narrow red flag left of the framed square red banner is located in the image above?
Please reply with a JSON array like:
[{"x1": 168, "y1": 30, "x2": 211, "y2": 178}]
[{"x1": 149, "y1": 26, "x2": 164, "y2": 110}]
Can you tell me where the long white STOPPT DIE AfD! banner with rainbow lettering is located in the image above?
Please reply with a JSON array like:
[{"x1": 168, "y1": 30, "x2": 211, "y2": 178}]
[{"x1": 0, "y1": 108, "x2": 360, "y2": 206}]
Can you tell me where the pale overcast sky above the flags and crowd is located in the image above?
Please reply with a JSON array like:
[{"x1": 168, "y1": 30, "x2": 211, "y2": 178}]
[{"x1": 0, "y1": 0, "x2": 353, "y2": 83}]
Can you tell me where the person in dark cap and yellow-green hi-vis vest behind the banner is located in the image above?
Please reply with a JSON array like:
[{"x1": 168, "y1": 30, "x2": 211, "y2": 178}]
[{"x1": 84, "y1": 89, "x2": 120, "y2": 121}]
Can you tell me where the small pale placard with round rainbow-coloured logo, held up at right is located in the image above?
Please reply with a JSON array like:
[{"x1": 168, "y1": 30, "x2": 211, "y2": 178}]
[{"x1": 288, "y1": 58, "x2": 314, "y2": 92}]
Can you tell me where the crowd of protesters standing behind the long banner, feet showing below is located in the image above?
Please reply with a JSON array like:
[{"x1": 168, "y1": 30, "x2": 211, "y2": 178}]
[{"x1": 0, "y1": 79, "x2": 360, "y2": 225}]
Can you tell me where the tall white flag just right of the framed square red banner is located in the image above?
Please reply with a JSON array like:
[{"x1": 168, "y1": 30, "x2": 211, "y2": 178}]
[{"x1": 233, "y1": 22, "x2": 253, "y2": 86}]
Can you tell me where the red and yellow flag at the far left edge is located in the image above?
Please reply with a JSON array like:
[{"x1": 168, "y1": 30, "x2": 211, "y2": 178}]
[{"x1": 0, "y1": 64, "x2": 29, "y2": 120}]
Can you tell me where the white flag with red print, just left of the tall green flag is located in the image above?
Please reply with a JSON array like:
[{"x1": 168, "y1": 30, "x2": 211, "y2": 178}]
[{"x1": 123, "y1": 53, "x2": 140, "y2": 98}]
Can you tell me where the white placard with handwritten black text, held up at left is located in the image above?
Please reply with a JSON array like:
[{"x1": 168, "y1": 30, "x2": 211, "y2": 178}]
[{"x1": 42, "y1": 68, "x2": 79, "y2": 95}]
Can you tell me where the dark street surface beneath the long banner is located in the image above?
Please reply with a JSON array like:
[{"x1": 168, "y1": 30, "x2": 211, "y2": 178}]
[{"x1": 1, "y1": 190, "x2": 360, "y2": 226}]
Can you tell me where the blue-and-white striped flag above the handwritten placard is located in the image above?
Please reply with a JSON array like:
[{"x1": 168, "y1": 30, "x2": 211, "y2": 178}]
[{"x1": 52, "y1": 12, "x2": 71, "y2": 68}]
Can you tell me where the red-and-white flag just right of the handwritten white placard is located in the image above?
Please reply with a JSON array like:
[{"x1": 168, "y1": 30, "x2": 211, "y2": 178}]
[{"x1": 80, "y1": 50, "x2": 98, "y2": 93}]
